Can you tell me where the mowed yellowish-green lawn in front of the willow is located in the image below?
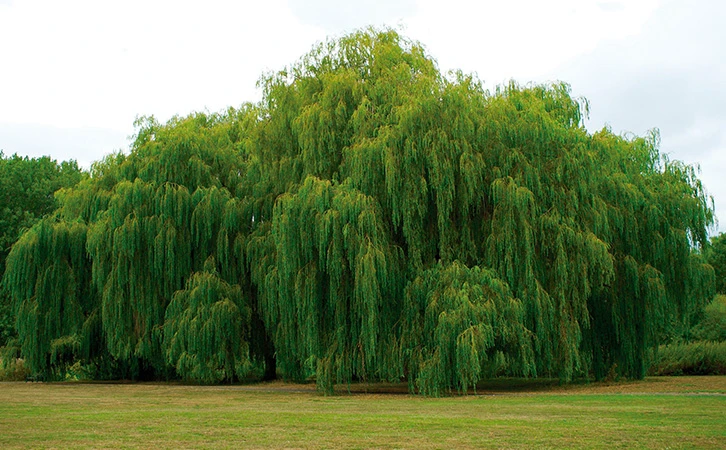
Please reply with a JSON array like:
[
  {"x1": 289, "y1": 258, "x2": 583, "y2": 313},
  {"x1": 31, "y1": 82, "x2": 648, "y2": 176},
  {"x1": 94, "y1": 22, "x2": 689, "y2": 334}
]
[{"x1": 0, "y1": 376, "x2": 726, "y2": 449}]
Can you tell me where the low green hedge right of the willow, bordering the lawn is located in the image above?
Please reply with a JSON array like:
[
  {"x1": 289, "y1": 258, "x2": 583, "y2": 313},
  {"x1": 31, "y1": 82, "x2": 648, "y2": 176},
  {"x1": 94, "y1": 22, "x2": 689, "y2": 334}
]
[{"x1": 649, "y1": 342, "x2": 726, "y2": 375}]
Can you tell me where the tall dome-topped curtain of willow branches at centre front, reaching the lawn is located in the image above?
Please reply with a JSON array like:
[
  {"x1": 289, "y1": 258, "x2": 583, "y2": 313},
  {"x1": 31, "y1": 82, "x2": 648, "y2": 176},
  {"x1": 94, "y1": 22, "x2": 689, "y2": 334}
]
[{"x1": 260, "y1": 177, "x2": 404, "y2": 390}]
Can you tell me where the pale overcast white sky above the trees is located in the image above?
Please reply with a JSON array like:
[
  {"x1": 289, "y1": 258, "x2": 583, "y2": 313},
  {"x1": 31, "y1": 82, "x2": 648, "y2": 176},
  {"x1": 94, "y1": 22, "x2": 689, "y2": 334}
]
[{"x1": 0, "y1": 0, "x2": 726, "y2": 231}]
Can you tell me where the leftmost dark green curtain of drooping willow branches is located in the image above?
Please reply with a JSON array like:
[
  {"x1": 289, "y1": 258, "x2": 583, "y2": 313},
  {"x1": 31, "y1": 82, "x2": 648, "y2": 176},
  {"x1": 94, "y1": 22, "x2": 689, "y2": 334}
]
[{"x1": 4, "y1": 217, "x2": 97, "y2": 376}]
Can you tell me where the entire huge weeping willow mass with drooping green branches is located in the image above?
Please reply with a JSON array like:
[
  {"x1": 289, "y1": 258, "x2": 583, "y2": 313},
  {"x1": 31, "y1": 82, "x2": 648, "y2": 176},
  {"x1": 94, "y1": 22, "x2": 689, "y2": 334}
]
[{"x1": 5, "y1": 30, "x2": 713, "y2": 395}]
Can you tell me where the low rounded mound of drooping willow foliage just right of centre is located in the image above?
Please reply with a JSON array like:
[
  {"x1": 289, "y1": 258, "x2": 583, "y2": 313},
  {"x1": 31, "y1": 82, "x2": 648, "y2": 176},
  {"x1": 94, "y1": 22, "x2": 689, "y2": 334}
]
[{"x1": 402, "y1": 261, "x2": 536, "y2": 395}]
